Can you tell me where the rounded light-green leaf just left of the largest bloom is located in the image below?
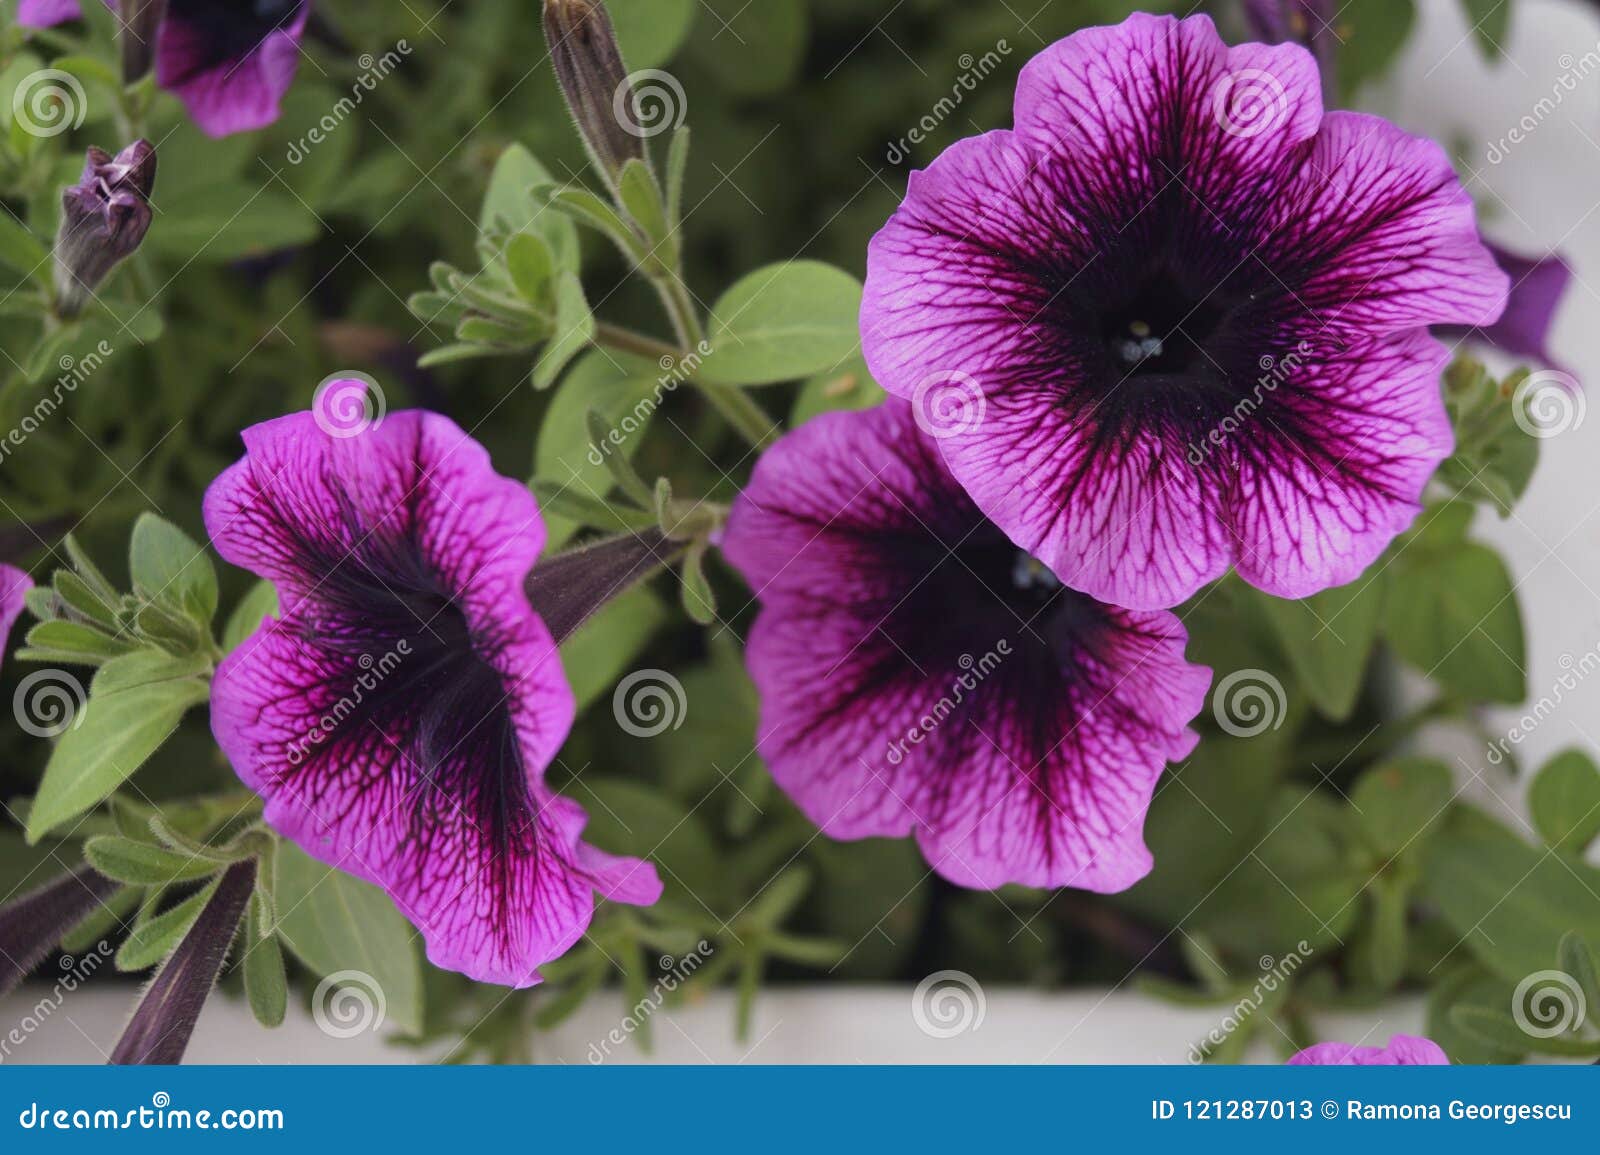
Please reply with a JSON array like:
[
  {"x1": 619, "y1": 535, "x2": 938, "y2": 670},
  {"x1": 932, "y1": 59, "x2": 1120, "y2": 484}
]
[{"x1": 698, "y1": 261, "x2": 861, "y2": 386}]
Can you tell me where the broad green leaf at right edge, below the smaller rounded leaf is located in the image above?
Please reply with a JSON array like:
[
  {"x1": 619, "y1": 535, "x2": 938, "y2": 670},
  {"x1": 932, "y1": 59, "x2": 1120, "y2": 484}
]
[{"x1": 1421, "y1": 806, "x2": 1600, "y2": 982}]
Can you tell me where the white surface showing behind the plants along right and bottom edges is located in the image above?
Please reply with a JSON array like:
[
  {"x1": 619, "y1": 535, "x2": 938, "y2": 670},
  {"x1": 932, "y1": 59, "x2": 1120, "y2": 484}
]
[{"x1": 0, "y1": 0, "x2": 1600, "y2": 1064}]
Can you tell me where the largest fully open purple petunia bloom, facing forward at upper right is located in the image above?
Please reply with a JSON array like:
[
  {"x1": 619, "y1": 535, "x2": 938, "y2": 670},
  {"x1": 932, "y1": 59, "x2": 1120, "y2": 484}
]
[{"x1": 861, "y1": 14, "x2": 1506, "y2": 608}]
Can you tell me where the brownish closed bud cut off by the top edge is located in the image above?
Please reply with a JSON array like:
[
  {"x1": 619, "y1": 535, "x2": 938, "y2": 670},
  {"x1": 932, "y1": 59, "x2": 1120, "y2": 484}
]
[{"x1": 544, "y1": 0, "x2": 645, "y2": 186}]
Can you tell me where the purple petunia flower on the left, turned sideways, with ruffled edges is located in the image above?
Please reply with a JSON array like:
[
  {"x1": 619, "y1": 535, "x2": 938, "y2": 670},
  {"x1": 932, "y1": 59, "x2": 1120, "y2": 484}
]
[{"x1": 205, "y1": 396, "x2": 661, "y2": 987}]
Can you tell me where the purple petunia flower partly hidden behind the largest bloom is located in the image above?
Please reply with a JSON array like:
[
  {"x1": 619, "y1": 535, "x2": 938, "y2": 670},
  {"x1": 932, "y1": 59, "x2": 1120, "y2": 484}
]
[{"x1": 723, "y1": 398, "x2": 1211, "y2": 891}]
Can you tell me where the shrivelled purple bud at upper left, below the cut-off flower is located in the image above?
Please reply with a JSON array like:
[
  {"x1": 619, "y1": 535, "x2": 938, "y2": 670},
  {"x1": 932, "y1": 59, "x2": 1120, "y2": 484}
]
[{"x1": 56, "y1": 141, "x2": 155, "y2": 317}]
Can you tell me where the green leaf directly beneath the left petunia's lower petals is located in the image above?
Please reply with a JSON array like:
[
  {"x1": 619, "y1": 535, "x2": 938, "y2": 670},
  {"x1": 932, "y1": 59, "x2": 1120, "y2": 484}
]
[{"x1": 272, "y1": 843, "x2": 422, "y2": 1033}]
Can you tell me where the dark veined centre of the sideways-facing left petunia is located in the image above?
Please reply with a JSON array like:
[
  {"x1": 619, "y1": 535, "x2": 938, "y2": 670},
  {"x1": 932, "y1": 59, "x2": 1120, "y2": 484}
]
[{"x1": 283, "y1": 463, "x2": 538, "y2": 897}]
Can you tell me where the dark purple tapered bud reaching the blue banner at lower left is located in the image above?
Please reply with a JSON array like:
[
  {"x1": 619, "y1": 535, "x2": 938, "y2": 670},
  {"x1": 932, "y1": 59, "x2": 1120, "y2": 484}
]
[{"x1": 110, "y1": 861, "x2": 256, "y2": 1065}]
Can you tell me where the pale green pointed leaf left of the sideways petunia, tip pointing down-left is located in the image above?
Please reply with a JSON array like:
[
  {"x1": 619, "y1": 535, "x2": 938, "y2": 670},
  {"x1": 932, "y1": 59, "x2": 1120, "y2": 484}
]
[{"x1": 27, "y1": 665, "x2": 211, "y2": 841}]
